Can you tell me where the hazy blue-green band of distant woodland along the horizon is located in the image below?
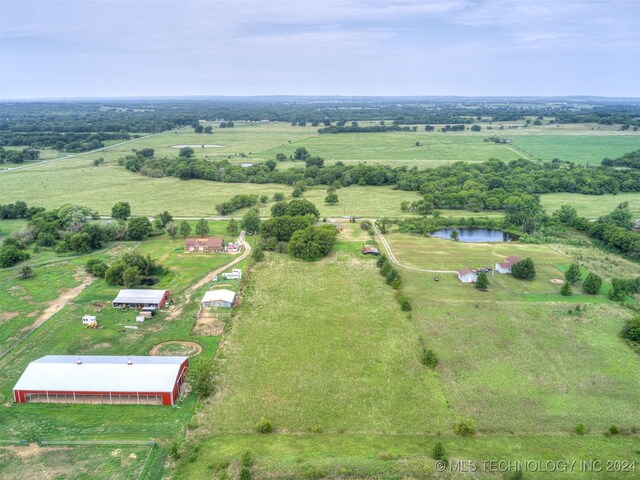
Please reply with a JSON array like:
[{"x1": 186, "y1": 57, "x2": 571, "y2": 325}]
[{"x1": 0, "y1": 97, "x2": 640, "y2": 133}]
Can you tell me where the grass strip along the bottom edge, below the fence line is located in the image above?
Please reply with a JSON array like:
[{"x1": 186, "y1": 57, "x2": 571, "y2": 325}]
[{"x1": 174, "y1": 434, "x2": 640, "y2": 480}]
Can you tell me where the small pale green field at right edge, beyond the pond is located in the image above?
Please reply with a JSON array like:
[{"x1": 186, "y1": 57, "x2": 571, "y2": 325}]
[{"x1": 540, "y1": 193, "x2": 640, "y2": 218}]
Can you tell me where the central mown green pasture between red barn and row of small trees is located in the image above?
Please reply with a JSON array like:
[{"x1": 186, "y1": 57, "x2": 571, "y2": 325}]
[{"x1": 199, "y1": 253, "x2": 450, "y2": 433}]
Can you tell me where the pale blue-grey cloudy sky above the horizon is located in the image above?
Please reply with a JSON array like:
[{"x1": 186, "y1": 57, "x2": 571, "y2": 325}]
[{"x1": 0, "y1": 0, "x2": 640, "y2": 99}]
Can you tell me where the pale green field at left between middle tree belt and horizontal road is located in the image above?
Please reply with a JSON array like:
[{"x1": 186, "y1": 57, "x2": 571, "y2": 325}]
[{"x1": 0, "y1": 160, "x2": 420, "y2": 218}]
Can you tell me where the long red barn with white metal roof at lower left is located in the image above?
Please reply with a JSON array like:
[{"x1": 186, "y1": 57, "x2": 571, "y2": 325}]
[{"x1": 13, "y1": 355, "x2": 189, "y2": 405}]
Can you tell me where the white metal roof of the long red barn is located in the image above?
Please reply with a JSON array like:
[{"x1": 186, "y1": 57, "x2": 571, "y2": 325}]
[{"x1": 13, "y1": 355, "x2": 188, "y2": 392}]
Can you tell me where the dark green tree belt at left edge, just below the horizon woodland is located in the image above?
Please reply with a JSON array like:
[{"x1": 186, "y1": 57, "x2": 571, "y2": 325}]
[{"x1": 0, "y1": 132, "x2": 137, "y2": 153}]
